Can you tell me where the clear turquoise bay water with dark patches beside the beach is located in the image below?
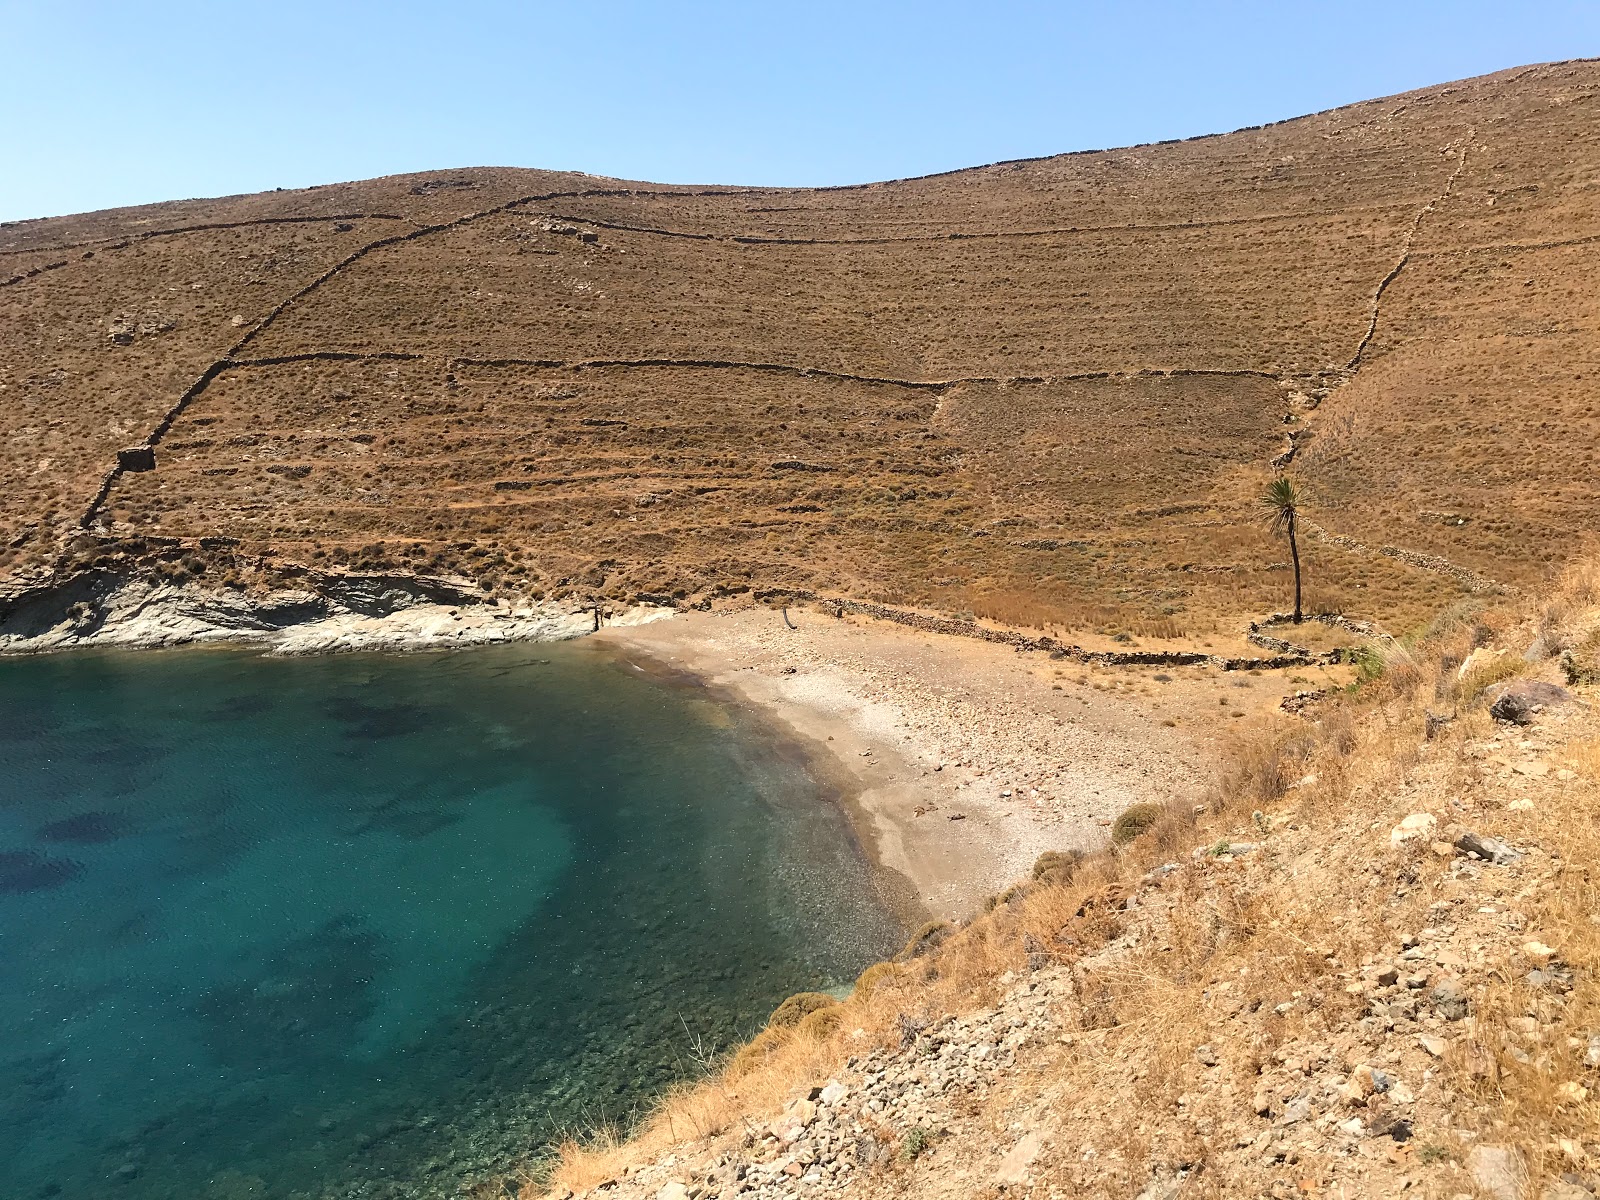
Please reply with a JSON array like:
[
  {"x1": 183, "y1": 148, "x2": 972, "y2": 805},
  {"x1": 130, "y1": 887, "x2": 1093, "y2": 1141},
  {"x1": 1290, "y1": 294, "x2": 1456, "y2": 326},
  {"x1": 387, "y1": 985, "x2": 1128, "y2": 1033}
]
[{"x1": 0, "y1": 643, "x2": 902, "y2": 1200}]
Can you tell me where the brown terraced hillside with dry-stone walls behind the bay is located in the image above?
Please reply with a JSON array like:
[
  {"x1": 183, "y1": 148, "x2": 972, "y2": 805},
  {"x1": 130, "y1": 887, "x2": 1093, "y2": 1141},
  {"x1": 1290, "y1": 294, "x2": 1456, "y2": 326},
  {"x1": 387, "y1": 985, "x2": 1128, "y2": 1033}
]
[{"x1": 0, "y1": 62, "x2": 1600, "y2": 635}]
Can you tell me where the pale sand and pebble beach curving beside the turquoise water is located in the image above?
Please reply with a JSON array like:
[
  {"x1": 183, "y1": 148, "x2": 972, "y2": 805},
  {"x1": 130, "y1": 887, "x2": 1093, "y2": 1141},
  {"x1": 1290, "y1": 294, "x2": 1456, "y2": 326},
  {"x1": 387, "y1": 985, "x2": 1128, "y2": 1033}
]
[{"x1": 595, "y1": 608, "x2": 1228, "y2": 918}]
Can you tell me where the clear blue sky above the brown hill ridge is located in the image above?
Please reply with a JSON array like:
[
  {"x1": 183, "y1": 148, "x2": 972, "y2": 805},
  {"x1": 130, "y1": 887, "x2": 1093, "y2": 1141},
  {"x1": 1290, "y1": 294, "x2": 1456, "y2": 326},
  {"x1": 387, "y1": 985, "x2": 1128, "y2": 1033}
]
[{"x1": 9, "y1": 0, "x2": 1600, "y2": 219}]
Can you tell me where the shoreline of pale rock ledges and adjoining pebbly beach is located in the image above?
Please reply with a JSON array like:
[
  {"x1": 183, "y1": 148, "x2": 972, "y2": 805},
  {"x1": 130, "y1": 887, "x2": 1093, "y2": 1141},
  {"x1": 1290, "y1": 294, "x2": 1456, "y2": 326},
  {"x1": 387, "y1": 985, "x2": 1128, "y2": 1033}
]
[{"x1": 0, "y1": 574, "x2": 1245, "y2": 925}]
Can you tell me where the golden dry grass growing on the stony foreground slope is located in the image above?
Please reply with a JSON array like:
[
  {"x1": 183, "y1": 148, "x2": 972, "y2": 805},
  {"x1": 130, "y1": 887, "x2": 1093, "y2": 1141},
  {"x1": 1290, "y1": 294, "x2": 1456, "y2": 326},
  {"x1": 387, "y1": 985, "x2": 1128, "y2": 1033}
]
[{"x1": 544, "y1": 563, "x2": 1600, "y2": 1197}]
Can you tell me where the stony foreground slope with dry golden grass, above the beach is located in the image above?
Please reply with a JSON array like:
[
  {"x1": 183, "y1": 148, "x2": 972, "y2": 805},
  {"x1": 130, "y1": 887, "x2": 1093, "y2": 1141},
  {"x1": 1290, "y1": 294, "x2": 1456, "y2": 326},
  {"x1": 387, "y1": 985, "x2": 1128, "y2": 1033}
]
[{"x1": 540, "y1": 565, "x2": 1600, "y2": 1200}]
